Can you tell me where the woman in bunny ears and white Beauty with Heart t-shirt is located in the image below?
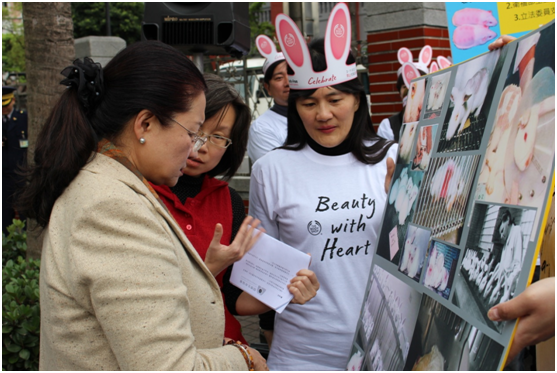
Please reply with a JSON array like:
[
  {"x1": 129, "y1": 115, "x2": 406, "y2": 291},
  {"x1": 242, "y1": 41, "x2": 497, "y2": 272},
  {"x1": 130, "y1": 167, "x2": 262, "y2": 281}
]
[{"x1": 250, "y1": 3, "x2": 397, "y2": 370}]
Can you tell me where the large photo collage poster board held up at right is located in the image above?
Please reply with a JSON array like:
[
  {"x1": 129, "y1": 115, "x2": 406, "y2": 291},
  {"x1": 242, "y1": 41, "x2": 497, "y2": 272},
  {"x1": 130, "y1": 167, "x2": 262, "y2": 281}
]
[{"x1": 347, "y1": 21, "x2": 555, "y2": 370}]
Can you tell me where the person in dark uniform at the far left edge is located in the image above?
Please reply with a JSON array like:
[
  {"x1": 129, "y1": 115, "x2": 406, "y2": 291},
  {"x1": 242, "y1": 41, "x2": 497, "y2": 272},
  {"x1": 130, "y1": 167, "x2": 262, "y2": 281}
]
[{"x1": 2, "y1": 87, "x2": 29, "y2": 234}]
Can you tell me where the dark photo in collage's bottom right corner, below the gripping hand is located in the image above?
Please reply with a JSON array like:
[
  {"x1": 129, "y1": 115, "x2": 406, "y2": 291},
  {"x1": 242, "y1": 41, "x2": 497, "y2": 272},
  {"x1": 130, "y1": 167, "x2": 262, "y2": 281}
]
[{"x1": 404, "y1": 294, "x2": 503, "y2": 371}]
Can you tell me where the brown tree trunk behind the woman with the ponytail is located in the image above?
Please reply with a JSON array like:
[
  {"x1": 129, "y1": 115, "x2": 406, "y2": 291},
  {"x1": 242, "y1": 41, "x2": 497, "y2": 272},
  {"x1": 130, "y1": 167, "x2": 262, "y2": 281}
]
[{"x1": 22, "y1": 2, "x2": 75, "y2": 258}]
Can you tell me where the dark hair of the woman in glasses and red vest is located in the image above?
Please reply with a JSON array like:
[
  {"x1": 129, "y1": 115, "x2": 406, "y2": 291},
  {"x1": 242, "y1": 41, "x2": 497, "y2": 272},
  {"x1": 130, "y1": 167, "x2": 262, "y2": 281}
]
[{"x1": 204, "y1": 74, "x2": 251, "y2": 180}]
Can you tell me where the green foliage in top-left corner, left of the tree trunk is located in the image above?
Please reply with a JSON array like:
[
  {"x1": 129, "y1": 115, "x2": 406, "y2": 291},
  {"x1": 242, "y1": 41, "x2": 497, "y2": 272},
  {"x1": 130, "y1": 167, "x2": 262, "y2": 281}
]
[{"x1": 2, "y1": 3, "x2": 25, "y2": 73}]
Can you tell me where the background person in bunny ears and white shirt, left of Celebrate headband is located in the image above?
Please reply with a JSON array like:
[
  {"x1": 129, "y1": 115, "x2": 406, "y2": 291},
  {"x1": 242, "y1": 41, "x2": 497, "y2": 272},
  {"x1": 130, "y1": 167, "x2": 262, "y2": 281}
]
[{"x1": 248, "y1": 36, "x2": 290, "y2": 163}]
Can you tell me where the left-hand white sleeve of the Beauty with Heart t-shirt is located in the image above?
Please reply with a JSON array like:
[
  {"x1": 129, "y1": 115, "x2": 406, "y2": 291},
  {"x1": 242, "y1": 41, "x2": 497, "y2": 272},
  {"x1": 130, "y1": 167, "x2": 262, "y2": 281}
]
[{"x1": 249, "y1": 162, "x2": 279, "y2": 239}]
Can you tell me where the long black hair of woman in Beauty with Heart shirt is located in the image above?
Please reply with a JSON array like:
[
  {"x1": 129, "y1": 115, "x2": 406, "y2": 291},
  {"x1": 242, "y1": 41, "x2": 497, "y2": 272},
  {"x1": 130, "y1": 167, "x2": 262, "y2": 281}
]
[{"x1": 282, "y1": 38, "x2": 394, "y2": 164}]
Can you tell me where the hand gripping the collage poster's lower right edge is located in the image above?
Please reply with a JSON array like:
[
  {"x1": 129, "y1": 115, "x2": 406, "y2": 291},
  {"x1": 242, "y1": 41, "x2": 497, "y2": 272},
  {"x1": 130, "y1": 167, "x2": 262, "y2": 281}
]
[{"x1": 487, "y1": 277, "x2": 555, "y2": 362}]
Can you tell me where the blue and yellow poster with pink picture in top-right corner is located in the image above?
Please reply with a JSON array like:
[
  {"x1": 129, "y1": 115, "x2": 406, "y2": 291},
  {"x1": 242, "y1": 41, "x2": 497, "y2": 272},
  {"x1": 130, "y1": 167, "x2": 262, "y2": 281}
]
[{"x1": 445, "y1": 2, "x2": 555, "y2": 63}]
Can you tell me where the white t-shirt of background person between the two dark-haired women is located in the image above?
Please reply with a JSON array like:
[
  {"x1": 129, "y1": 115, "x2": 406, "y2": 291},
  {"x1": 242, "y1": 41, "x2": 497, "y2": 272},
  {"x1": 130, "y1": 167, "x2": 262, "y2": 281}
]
[{"x1": 248, "y1": 110, "x2": 288, "y2": 163}]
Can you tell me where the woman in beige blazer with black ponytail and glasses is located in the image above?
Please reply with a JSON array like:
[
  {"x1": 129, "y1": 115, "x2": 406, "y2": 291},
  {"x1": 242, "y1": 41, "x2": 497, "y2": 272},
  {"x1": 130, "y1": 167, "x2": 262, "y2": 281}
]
[{"x1": 19, "y1": 41, "x2": 267, "y2": 371}]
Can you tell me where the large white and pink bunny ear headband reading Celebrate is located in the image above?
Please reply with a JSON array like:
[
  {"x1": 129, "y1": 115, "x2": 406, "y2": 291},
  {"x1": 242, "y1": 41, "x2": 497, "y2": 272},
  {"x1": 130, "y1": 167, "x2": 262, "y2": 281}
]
[{"x1": 275, "y1": 3, "x2": 357, "y2": 89}]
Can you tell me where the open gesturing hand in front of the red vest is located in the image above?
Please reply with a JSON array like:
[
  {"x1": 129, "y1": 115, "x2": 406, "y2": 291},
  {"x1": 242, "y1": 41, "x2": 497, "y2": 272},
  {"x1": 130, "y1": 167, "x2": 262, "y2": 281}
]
[{"x1": 205, "y1": 216, "x2": 264, "y2": 276}]
